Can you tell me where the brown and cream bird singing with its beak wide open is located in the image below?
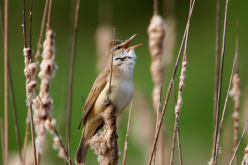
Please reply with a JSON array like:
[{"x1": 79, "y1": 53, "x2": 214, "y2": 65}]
[{"x1": 75, "y1": 34, "x2": 142, "y2": 165}]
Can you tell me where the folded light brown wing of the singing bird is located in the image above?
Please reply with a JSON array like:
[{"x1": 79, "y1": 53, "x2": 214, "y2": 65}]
[{"x1": 82, "y1": 69, "x2": 109, "y2": 120}]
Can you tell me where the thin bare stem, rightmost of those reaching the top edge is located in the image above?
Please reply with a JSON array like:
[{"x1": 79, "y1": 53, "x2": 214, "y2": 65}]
[{"x1": 213, "y1": 0, "x2": 229, "y2": 165}]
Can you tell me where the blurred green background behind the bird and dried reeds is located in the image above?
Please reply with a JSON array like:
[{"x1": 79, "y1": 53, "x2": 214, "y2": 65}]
[{"x1": 0, "y1": 0, "x2": 248, "y2": 165}]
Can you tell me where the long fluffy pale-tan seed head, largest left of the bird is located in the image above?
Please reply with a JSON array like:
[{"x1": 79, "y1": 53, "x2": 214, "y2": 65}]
[{"x1": 33, "y1": 29, "x2": 68, "y2": 160}]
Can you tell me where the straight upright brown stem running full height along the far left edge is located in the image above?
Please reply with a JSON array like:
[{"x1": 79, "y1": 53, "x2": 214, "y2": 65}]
[{"x1": 4, "y1": 0, "x2": 9, "y2": 165}]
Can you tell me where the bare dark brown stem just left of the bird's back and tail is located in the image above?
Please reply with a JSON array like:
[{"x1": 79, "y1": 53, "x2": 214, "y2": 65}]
[{"x1": 67, "y1": 0, "x2": 80, "y2": 153}]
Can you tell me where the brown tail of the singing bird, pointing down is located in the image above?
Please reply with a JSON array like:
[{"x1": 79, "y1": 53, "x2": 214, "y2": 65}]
[{"x1": 75, "y1": 123, "x2": 89, "y2": 165}]
